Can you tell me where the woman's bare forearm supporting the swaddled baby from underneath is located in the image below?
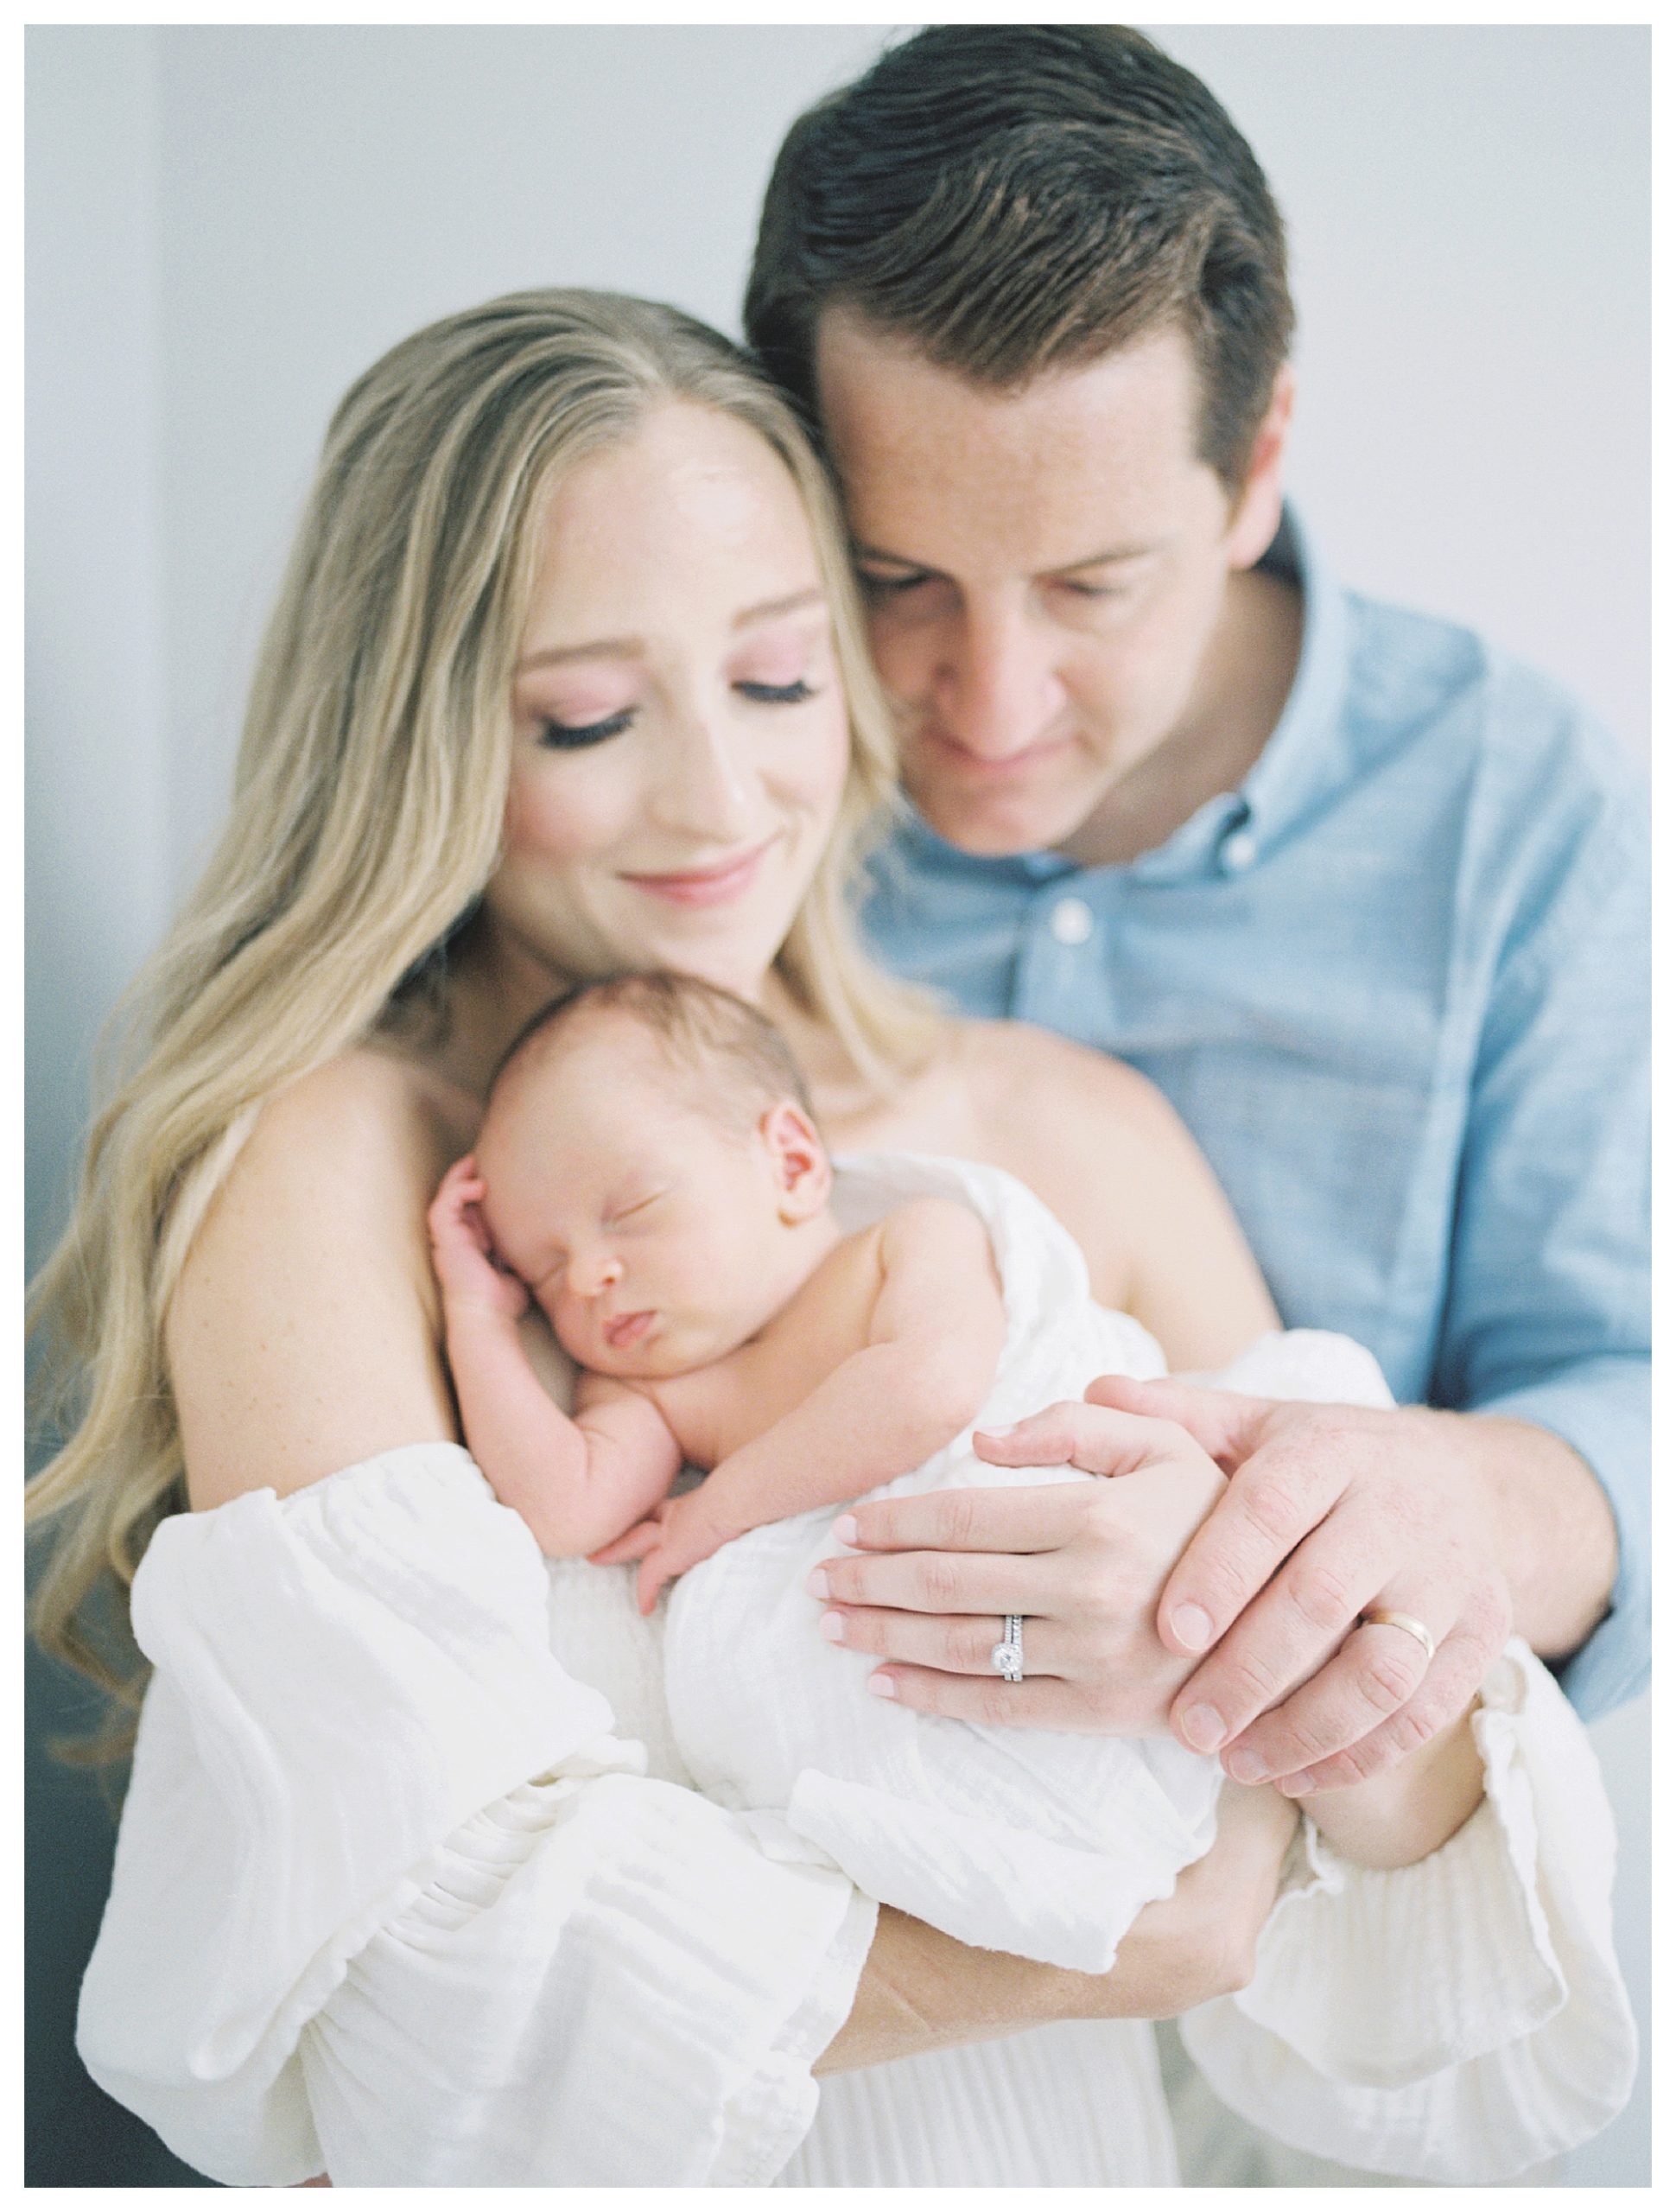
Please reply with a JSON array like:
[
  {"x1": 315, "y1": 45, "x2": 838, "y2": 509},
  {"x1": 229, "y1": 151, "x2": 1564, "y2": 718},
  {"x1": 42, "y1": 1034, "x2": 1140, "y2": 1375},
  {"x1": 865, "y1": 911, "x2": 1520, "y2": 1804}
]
[{"x1": 814, "y1": 1783, "x2": 1298, "y2": 2075}]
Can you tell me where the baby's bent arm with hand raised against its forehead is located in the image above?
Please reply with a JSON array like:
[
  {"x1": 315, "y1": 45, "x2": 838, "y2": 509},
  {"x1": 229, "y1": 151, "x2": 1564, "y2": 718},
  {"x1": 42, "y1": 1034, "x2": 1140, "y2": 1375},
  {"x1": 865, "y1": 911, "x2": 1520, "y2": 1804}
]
[{"x1": 429, "y1": 1157, "x2": 681, "y2": 1560}]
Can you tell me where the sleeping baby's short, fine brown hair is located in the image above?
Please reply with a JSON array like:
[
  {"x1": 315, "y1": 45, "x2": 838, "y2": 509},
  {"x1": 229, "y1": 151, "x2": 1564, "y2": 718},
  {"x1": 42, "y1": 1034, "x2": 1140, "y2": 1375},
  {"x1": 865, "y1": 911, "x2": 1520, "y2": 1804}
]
[{"x1": 489, "y1": 969, "x2": 814, "y2": 1122}]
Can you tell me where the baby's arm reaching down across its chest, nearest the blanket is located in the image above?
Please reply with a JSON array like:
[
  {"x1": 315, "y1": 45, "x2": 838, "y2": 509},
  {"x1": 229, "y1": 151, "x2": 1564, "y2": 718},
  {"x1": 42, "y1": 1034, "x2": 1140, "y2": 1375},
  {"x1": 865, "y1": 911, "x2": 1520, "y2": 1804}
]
[{"x1": 610, "y1": 1199, "x2": 1006, "y2": 1611}]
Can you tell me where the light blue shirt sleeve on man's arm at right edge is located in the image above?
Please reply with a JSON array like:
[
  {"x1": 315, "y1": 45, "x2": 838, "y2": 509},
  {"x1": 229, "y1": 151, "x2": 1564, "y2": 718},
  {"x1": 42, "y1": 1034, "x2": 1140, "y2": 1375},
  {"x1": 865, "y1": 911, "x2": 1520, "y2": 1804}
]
[{"x1": 1432, "y1": 690, "x2": 1652, "y2": 1719}]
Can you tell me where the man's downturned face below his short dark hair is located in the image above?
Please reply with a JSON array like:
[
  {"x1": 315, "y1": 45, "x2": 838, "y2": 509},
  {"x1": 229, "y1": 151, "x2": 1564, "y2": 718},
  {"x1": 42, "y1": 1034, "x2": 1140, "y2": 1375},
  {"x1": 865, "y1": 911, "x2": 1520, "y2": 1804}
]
[{"x1": 818, "y1": 309, "x2": 1278, "y2": 854}]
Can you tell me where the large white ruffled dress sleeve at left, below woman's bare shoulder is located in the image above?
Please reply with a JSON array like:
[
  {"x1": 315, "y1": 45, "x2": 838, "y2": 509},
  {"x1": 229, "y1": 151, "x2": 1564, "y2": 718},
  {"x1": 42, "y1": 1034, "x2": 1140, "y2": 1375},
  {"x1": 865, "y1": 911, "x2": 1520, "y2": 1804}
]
[{"x1": 78, "y1": 1445, "x2": 873, "y2": 2185}]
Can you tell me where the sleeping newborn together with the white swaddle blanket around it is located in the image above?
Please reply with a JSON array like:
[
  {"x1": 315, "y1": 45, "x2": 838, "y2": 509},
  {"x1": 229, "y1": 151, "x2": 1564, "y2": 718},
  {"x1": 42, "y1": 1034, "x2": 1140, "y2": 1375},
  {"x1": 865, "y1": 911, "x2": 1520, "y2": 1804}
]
[{"x1": 429, "y1": 976, "x2": 1391, "y2": 1971}]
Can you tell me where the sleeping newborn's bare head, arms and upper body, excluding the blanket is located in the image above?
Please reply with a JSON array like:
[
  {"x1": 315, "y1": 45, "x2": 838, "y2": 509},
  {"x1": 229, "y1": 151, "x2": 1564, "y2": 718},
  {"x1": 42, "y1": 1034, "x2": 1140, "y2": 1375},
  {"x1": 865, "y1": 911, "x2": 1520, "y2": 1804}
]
[{"x1": 429, "y1": 976, "x2": 1006, "y2": 1612}]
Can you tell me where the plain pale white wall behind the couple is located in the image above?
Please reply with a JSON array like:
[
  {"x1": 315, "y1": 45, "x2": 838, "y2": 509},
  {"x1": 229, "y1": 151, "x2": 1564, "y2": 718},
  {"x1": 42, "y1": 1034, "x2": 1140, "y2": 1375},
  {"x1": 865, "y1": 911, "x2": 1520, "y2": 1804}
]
[{"x1": 29, "y1": 24, "x2": 1649, "y2": 2183}]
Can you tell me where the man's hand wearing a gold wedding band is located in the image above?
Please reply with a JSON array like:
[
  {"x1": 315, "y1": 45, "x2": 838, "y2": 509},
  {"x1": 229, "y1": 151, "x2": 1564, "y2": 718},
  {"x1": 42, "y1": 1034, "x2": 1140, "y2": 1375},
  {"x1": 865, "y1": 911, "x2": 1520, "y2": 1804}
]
[{"x1": 1088, "y1": 1376, "x2": 1513, "y2": 1796}]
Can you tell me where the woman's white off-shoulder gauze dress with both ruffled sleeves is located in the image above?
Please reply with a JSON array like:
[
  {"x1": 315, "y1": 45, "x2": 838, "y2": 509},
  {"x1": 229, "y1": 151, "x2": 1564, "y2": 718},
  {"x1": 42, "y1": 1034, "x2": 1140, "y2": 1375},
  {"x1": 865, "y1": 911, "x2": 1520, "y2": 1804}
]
[{"x1": 79, "y1": 1445, "x2": 1634, "y2": 2188}]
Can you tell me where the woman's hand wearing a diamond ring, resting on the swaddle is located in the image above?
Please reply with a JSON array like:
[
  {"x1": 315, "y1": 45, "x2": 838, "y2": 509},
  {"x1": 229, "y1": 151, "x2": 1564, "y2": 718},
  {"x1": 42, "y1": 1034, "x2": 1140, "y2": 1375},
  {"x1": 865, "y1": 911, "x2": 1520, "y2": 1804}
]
[{"x1": 811, "y1": 1402, "x2": 1227, "y2": 1737}]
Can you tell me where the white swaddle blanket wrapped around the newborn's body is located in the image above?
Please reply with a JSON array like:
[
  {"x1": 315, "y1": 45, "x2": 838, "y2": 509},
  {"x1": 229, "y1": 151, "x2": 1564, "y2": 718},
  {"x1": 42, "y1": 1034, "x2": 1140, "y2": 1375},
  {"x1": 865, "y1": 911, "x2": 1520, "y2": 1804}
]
[{"x1": 663, "y1": 1153, "x2": 1391, "y2": 1974}]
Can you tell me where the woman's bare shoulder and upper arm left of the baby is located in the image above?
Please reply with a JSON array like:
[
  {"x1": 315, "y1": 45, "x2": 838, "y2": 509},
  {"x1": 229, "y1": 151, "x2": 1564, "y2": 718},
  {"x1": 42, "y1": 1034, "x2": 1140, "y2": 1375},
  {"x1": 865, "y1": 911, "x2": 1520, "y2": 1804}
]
[{"x1": 168, "y1": 1048, "x2": 471, "y2": 1504}]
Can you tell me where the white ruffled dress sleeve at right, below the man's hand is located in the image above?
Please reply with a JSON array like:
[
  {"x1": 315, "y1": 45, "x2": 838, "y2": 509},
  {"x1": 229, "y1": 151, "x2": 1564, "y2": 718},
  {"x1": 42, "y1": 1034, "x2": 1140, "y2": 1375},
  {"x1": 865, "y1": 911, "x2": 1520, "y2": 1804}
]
[{"x1": 1181, "y1": 1642, "x2": 1636, "y2": 2183}]
